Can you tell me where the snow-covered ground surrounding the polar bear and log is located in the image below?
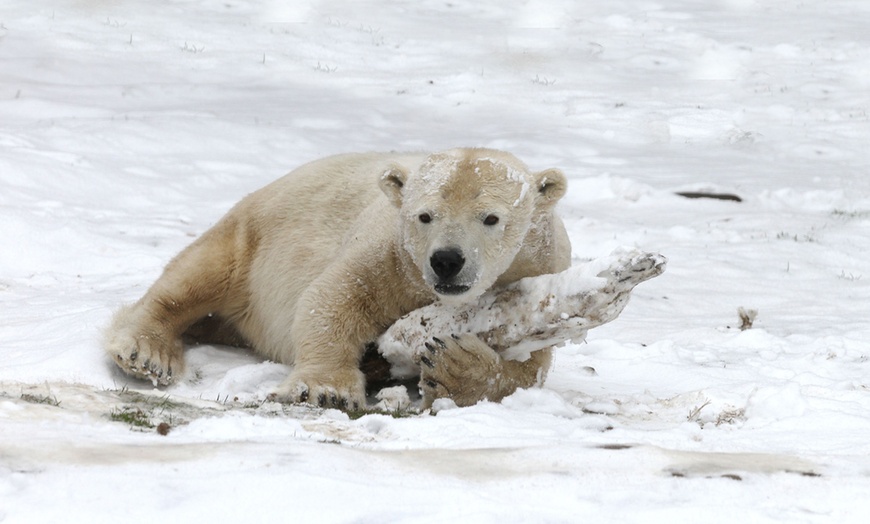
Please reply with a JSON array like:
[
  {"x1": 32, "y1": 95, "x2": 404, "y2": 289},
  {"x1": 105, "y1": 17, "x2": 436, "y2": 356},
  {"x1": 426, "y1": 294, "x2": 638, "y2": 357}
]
[{"x1": 0, "y1": 0, "x2": 870, "y2": 523}]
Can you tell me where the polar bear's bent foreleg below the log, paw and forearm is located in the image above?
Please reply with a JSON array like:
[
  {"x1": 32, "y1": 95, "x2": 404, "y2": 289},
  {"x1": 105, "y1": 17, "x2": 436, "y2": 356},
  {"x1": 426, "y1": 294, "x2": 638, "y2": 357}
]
[{"x1": 417, "y1": 335, "x2": 552, "y2": 409}]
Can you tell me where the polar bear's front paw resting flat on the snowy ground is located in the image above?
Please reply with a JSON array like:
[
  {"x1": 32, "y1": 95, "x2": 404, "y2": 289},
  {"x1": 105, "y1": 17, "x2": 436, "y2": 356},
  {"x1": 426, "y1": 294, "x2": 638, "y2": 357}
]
[{"x1": 269, "y1": 369, "x2": 366, "y2": 411}]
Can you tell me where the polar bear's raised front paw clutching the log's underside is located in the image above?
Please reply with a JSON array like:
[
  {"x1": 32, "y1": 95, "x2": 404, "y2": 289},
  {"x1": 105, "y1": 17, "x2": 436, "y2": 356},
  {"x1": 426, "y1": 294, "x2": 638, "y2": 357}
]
[{"x1": 416, "y1": 335, "x2": 502, "y2": 409}]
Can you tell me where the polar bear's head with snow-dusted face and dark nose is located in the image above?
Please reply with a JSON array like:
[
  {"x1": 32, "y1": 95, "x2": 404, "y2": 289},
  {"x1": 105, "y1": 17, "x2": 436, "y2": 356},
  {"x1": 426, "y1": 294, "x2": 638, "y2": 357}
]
[{"x1": 380, "y1": 149, "x2": 567, "y2": 302}]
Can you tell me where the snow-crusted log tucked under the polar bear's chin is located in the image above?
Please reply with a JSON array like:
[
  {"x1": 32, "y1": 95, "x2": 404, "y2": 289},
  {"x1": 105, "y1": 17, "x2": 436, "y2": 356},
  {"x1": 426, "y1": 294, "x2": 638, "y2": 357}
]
[{"x1": 377, "y1": 251, "x2": 667, "y2": 378}]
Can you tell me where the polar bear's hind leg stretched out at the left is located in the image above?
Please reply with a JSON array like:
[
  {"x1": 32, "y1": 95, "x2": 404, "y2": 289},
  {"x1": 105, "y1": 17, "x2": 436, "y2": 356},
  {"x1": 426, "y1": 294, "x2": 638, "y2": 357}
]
[{"x1": 103, "y1": 223, "x2": 252, "y2": 385}]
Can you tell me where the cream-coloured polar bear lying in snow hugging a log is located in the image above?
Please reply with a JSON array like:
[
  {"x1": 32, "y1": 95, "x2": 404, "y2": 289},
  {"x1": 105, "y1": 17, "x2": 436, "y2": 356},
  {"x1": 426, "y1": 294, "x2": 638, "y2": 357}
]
[{"x1": 103, "y1": 148, "x2": 570, "y2": 409}]
